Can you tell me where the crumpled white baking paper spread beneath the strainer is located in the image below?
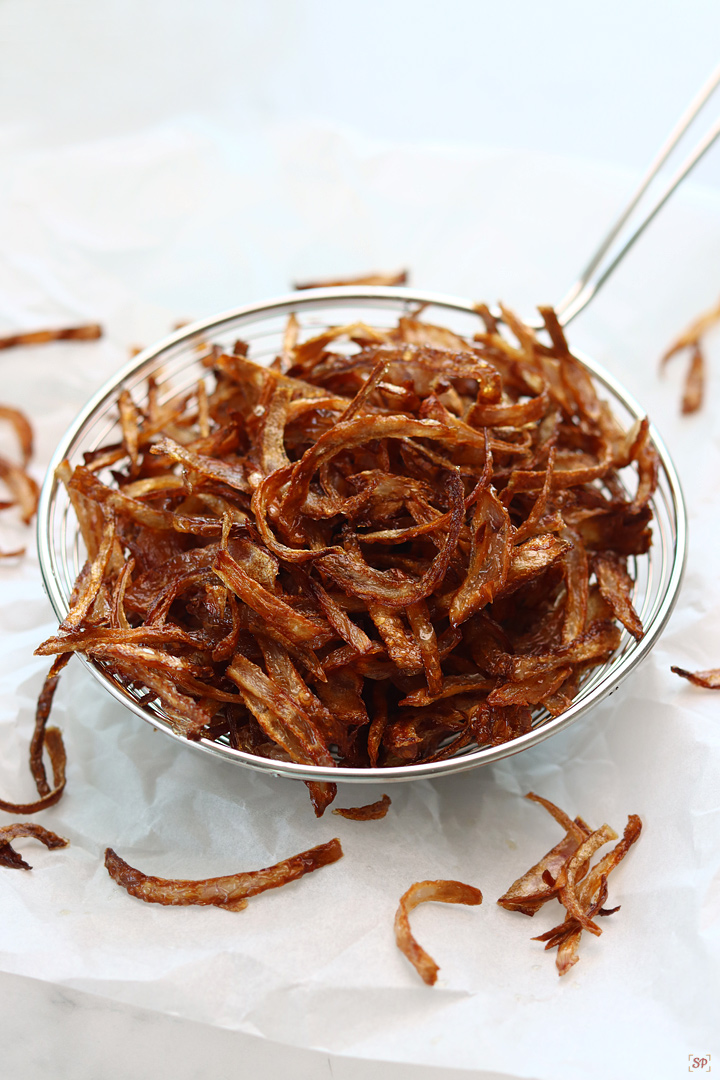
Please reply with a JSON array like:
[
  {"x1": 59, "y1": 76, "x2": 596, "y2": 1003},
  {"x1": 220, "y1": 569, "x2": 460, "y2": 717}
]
[{"x1": 0, "y1": 119, "x2": 720, "y2": 1080}]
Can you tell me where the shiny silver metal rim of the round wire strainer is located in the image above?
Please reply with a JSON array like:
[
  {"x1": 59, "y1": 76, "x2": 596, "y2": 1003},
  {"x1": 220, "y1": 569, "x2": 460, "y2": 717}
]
[{"x1": 37, "y1": 287, "x2": 688, "y2": 783}]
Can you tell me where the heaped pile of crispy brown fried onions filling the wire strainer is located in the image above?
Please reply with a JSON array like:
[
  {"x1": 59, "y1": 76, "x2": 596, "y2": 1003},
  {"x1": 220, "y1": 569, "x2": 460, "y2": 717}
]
[{"x1": 38, "y1": 306, "x2": 658, "y2": 812}]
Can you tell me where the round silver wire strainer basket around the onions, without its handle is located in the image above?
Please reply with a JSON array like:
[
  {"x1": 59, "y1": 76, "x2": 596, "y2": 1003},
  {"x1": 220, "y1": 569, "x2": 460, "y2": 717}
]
[{"x1": 38, "y1": 287, "x2": 687, "y2": 783}]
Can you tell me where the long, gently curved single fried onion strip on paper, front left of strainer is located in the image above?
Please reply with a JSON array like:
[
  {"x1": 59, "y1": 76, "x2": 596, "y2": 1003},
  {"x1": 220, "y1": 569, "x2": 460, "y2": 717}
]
[{"x1": 105, "y1": 839, "x2": 342, "y2": 912}]
